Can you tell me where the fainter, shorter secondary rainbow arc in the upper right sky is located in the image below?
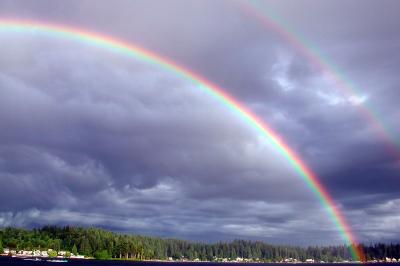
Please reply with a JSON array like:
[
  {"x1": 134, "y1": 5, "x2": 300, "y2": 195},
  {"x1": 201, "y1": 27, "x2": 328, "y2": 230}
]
[{"x1": 236, "y1": 0, "x2": 400, "y2": 160}]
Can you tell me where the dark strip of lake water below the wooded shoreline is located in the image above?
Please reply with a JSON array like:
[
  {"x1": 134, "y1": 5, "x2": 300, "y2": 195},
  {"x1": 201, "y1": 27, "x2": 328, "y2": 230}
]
[{"x1": 0, "y1": 257, "x2": 394, "y2": 266}]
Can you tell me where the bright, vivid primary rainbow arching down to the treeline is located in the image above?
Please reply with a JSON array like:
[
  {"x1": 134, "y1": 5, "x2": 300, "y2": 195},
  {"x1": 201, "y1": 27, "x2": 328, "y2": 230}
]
[{"x1": 0, "y1": 19, "x2": 364, "y2": 260}]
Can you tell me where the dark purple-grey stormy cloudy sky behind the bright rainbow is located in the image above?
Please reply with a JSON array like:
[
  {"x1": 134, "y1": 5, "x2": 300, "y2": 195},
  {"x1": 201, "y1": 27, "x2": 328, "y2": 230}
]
[{"x1": 0, "y1": 0, "x2": 400, "y2": 245}]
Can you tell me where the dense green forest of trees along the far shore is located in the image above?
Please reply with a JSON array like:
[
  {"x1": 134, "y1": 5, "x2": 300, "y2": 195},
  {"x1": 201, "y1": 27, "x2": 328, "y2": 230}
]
[{"x1": 0, "y1": 226, "x2": 400, "y2": 261}]
